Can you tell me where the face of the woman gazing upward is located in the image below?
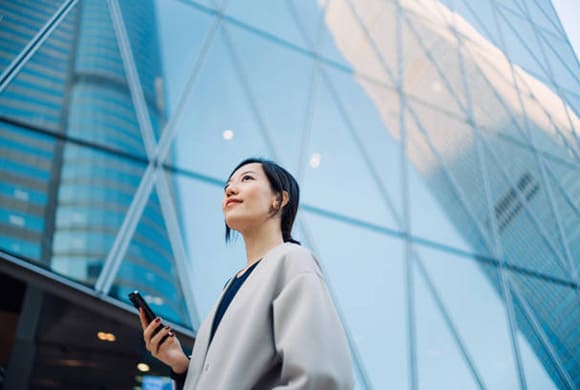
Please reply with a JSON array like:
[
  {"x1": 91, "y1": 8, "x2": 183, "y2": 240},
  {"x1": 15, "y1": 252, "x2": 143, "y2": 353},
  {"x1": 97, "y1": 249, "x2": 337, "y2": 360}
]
[{"x1": 222, "y1": 163, "x2": 277, "y2": 233}]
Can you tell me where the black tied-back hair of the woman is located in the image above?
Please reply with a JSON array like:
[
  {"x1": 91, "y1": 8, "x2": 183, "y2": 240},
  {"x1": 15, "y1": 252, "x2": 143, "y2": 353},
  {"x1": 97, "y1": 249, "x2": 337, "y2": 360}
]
[{"x1": 226, "y1": 157, "x2": 300, "y2": 245}]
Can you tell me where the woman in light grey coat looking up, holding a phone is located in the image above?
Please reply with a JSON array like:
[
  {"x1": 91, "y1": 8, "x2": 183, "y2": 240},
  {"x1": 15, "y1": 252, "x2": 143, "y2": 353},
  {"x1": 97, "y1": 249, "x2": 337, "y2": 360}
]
[{"x1": 140, "y1": 159, "x2": 354, "y2": 390}]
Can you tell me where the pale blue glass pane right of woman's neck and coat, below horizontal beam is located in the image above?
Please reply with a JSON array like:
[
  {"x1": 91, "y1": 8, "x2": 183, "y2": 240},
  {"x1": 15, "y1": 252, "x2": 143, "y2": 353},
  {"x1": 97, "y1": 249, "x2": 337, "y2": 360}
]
[{"x1": 301, "y1": 209, "x2": 409, "y2": 389}]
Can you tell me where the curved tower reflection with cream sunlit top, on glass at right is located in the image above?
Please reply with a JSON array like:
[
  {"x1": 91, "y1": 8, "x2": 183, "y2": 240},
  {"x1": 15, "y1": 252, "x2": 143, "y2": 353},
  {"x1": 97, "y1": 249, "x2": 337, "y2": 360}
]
[{"x1": 325, "y1": 1, "x2": 580, "y2": 388}]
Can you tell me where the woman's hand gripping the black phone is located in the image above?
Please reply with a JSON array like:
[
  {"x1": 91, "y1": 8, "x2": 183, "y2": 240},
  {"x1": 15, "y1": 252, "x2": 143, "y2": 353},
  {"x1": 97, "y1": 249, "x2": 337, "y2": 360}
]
[{"x1": 139, "y1": 309, "x2": 189, "y2": 374}]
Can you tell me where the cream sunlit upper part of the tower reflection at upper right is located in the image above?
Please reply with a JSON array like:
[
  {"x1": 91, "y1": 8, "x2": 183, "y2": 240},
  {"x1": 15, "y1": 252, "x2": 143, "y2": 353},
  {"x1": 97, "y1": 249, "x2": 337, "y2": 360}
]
[{"x1": 325, "y1": 0, "x2": 580, "y2": 173}]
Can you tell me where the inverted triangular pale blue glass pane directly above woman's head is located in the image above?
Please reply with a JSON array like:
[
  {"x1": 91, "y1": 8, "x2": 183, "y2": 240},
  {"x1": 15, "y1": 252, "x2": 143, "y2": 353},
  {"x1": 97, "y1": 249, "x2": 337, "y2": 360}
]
[{"x1": 227, "y1": 19, "x2": 320, "y2": 170}]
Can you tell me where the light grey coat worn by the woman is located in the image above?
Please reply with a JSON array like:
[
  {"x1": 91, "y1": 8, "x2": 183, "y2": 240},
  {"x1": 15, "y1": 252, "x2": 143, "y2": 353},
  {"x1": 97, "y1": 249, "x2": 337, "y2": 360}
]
[{"x1": 184, "y1": 243, "x2": 354, "y2": 390}]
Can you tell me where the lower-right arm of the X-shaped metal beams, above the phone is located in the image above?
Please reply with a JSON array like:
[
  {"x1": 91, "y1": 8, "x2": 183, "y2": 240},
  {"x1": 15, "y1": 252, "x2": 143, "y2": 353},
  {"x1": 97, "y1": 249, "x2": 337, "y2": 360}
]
[{"x1": 155, "y1": 168, "x2": 201, "y2": 330}]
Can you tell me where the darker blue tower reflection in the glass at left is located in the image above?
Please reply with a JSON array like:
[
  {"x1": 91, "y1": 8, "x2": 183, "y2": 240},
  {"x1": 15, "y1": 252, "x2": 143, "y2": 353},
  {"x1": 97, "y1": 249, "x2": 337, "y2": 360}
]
[{"x1": 0, "y1": 1, "x2": 191, "y2": 360}]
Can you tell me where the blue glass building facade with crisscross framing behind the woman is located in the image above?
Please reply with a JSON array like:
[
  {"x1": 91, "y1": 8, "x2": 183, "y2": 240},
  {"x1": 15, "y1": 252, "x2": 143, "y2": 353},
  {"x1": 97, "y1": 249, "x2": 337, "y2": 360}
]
[{"x1": 0, "y1": 0, "x2": 580, "y2": 389}]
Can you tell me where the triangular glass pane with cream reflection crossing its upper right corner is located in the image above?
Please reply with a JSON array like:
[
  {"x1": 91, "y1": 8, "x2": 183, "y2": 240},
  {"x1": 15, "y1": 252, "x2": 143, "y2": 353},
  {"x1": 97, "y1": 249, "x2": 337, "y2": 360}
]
[{"x1": 314, "y1": 61, "x2": 403, "y2": 219}]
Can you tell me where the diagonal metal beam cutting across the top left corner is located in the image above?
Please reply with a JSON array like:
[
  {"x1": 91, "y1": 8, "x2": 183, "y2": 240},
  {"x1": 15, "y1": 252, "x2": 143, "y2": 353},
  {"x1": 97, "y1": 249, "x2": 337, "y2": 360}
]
[{"x1": 0, "y1": 0, "x2": 78, "y2": 94}]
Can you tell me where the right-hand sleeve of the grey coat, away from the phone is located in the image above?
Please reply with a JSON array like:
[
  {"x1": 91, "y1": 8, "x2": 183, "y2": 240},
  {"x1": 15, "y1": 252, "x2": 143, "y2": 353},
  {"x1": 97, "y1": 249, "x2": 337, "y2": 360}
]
[{"x1": 273, "y1": 272, "x2": 354, "y2": 390}]
